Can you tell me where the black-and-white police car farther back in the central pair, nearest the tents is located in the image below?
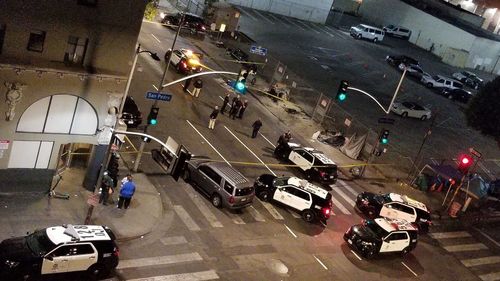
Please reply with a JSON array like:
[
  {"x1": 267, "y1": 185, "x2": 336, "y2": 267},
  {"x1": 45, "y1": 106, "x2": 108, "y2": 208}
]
[{"x1": 274, "y1": 142, "x2": 338, "y2": 184}]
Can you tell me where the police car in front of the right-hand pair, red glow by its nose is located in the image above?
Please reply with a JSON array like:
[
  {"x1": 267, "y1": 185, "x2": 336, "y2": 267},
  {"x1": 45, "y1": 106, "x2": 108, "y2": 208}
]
[{"x1": 344, "y1": 218, "x2": 418, "y2": 258}]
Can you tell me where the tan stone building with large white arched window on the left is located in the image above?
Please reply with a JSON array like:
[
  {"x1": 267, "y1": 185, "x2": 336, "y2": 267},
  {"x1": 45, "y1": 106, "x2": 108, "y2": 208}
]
[{"x1": 0, "y1": 0, "x2": 146, "y2": 192}]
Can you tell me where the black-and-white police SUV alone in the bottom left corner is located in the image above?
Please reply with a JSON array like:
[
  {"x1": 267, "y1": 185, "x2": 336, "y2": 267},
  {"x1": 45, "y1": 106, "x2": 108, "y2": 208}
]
[{"x1": 0, "y1": 225, "x2": 118, "y2": 280}]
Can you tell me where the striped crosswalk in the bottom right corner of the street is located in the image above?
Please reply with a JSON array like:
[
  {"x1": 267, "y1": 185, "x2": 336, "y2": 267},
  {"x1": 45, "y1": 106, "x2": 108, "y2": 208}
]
[{"x1": 429, "y1": 231, "x2": 500, "y2": 281}]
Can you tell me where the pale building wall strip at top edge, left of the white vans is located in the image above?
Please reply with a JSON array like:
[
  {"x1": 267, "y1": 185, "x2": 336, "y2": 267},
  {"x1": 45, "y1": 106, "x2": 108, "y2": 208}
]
[{"x1": 226, "y1": 0, "x2": 333, "y2": 24}]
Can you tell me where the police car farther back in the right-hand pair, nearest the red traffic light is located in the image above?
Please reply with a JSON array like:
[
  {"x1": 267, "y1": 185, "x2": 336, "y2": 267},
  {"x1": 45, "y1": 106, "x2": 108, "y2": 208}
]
[{"x1": 356, "y1": 191, "x2": 432, "y2": 233}]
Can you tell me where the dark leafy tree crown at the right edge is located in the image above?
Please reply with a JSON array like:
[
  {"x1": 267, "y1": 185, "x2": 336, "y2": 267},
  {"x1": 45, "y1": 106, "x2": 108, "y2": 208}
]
[{"x1": 465, "y1": 76, "x2": 500, "y2": 147}]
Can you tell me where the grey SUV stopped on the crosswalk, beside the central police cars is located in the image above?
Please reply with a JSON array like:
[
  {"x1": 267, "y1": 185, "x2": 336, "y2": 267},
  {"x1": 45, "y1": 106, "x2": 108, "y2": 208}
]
[{"x1": 183, "y1": 158, "x2": 255, "y2": 209}]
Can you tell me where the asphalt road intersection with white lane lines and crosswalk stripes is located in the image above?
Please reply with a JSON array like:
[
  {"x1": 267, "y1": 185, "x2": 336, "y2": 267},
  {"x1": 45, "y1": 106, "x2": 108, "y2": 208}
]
[{"x1": 98, "y1": 22, "x2": 500, "y2": 280}]
